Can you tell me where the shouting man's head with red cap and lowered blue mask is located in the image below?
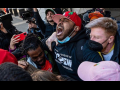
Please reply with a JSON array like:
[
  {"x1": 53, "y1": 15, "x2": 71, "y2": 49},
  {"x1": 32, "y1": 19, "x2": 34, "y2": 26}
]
[{"x1": 53, "y1": 11, "x2": 82, "y2": 43}]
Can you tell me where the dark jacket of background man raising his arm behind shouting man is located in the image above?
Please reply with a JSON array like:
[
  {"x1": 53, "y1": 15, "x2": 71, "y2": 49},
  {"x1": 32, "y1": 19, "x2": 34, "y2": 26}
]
[{"x1": 34, "y1": 12, "x2": 57, "y2": 38}]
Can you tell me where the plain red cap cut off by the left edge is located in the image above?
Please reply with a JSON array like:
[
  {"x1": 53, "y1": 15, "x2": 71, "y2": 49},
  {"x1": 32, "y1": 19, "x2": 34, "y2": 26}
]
[{"x1": 0, "y1": 49, "x2": 18, "y2": 65}]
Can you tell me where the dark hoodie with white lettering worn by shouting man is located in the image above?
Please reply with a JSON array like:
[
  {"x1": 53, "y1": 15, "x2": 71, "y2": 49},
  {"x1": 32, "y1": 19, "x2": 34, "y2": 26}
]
[{"x1": 44, "y1": 25, "x2": 88, "y2": 80}]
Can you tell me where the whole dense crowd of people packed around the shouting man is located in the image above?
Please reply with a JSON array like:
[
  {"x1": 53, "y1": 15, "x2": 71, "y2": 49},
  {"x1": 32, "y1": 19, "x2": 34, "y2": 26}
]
[{"x1": 0, "y1": 8, "x2": 120, "y2": 81}]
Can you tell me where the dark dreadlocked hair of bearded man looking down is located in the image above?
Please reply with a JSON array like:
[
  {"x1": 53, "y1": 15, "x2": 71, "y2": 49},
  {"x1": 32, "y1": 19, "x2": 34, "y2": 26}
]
[{"x1": 22, "y1": 33, "x2": 43, "y2": 54}]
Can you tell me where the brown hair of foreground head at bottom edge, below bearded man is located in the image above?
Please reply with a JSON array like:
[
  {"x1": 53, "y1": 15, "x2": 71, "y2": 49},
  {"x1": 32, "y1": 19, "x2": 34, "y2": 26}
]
[{"x1": 31, "y1": 70, "x2": 76, "y2": 81}]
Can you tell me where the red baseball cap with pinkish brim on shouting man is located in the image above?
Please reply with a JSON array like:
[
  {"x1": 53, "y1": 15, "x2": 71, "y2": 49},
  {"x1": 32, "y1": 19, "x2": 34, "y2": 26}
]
[{"x1": 52, "y1": 11, "x2": 82, "y2": 29}]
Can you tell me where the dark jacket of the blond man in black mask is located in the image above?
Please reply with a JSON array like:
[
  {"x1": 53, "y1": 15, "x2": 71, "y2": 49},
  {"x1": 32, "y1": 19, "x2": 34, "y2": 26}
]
[{"x1": 83, "y1": 33, "x2": 120, "y2": 64}]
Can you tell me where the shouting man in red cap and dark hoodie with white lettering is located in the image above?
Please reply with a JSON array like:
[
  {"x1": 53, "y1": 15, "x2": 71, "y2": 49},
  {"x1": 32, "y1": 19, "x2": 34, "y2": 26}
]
[{"x1": 43, "y1": 11, "x2": 87, "y2": 81}]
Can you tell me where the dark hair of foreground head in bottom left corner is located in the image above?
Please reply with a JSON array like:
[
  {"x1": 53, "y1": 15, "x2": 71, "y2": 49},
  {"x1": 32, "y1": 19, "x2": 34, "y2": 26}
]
[{"x1": 0, "y1": 62, "x2": 33, "y2": 81}]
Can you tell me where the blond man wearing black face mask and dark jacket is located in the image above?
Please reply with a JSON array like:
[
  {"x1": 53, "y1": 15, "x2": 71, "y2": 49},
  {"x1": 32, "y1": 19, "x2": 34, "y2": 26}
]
[{"x1": 83, "y1": 17, "x2": 120, "y2": 64}]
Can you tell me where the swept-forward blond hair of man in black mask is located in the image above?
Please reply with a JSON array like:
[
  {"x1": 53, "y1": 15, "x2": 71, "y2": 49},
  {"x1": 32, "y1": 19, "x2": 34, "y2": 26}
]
[{"x1": 85, "y1": 17, "x2": 118, "y2": 36}]
